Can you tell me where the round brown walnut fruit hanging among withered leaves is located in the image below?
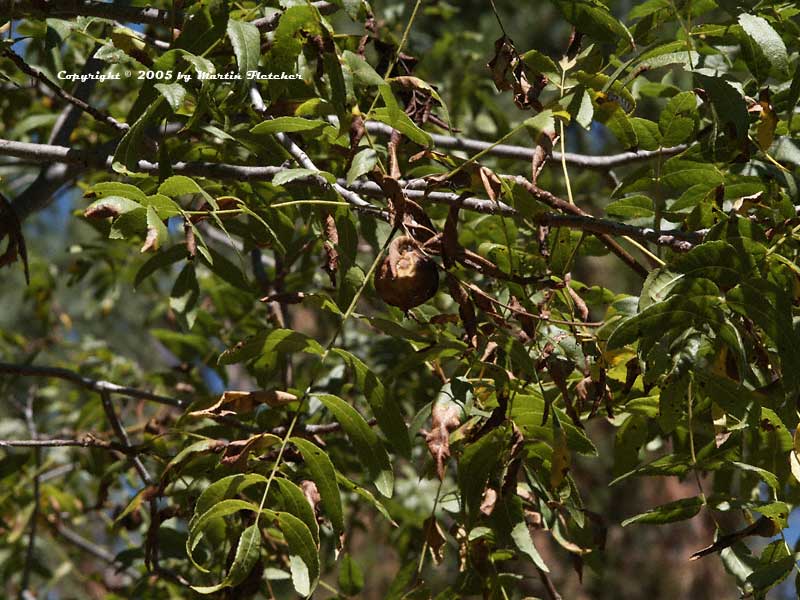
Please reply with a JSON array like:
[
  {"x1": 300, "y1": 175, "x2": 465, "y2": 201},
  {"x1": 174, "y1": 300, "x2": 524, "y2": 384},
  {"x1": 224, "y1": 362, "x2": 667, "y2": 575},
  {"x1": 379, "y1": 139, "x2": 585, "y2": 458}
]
[{"x1": 375, "y1": 236, "x2": 439, "y2": 311}]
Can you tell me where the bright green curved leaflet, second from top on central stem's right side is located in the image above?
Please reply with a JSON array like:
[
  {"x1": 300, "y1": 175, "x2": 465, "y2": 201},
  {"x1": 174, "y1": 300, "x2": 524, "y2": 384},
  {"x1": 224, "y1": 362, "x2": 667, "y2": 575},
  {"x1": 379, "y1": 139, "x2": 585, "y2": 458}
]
[{"x1": 314, "y1": 394, "x2": 394, "y2": 497}]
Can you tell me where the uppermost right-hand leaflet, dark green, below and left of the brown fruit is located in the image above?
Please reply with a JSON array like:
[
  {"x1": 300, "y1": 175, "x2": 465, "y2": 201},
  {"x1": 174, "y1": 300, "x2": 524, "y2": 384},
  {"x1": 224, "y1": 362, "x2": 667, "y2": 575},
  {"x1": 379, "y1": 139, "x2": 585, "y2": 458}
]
[{"x1": 333, "y1": 348, "x2": 411, "y2": 457}]
